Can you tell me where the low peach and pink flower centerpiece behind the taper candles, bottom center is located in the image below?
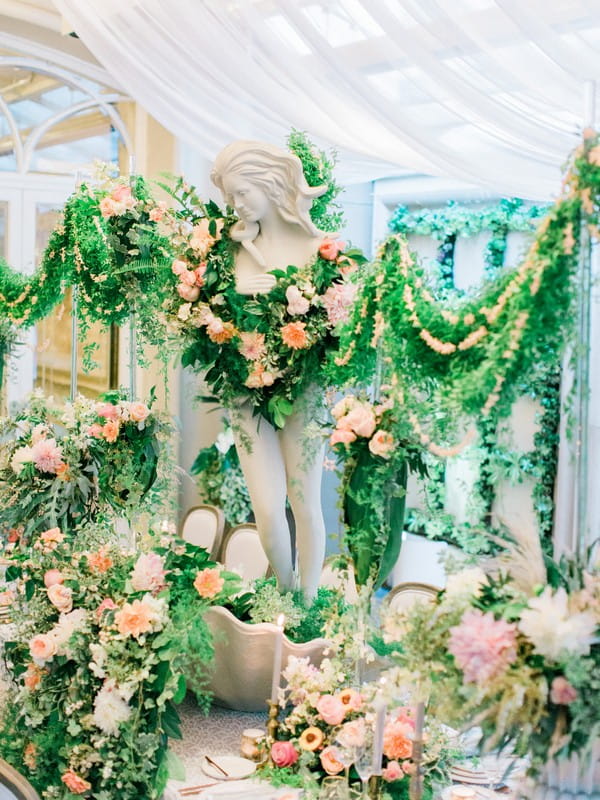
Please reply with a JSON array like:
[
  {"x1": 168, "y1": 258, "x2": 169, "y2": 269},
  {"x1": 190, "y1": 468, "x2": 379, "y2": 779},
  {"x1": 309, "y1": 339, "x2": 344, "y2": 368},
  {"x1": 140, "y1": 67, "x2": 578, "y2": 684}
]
[{"x1": 266, "y1": 657, "x2": 451, "y2": 799}]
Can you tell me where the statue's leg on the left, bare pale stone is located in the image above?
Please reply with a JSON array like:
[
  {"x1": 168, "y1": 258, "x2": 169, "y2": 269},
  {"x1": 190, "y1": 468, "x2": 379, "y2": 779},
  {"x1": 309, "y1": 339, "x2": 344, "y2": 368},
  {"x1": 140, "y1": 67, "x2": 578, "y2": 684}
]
[{"x1": 230, "y1": 404, "x2": 294, "y2": 590}]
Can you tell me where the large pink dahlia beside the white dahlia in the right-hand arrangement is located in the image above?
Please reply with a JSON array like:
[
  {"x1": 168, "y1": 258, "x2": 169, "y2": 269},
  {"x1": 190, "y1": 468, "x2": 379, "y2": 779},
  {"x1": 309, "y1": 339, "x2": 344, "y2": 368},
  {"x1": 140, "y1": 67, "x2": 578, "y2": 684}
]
[{"x1": 448, "y1": 609, "x2": 517, "y2": 686}]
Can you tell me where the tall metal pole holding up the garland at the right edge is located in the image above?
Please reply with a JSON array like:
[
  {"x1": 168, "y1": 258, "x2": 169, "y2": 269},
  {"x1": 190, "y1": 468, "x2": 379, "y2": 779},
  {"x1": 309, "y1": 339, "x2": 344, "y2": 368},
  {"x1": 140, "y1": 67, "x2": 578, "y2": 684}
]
[{"x1": 573, "y1": 81, "x2": 596, "y2": 557}]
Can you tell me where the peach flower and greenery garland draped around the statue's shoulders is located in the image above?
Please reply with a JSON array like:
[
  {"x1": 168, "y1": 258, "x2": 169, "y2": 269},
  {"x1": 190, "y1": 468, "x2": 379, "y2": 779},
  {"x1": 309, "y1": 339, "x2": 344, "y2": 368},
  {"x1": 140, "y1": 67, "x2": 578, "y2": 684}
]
[{"x1": 159, "y1": 136, "x2": 365, "y2": 428}]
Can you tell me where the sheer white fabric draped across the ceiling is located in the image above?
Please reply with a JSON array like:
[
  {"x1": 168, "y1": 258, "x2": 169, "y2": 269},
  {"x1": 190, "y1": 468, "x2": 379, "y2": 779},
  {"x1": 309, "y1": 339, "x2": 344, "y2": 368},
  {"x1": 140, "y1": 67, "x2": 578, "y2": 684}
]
[{"x1": 55, "y1": 0, "x2": 600, "y2": 199}]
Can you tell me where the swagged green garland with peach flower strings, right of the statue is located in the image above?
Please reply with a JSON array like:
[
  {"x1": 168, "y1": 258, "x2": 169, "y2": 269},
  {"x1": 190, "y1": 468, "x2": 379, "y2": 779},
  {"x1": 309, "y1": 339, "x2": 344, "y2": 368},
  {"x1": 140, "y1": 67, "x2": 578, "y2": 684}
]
[{"x1": 330, "y1": 132, "x2": 600, "y2": 457}]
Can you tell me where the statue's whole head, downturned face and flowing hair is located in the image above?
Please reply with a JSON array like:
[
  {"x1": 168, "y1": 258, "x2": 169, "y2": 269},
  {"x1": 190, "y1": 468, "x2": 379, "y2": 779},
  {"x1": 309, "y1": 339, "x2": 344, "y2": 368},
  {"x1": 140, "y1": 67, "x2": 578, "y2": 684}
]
[{"x1": 211, "y1": 140, "x2": 327, "y2": 241}]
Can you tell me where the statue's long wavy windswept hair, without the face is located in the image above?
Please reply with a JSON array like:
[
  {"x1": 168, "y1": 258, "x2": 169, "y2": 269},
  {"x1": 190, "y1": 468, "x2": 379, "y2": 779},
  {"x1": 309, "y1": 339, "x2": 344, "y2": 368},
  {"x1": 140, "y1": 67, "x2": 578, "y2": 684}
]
[{"x1": 210, "y1": 140, "x2": 327, "y2": 242}]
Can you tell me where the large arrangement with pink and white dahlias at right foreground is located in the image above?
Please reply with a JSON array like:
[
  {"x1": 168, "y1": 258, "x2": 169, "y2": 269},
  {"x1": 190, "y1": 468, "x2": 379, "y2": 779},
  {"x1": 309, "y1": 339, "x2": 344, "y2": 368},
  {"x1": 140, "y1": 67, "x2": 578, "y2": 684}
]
[{"x1": 384, "y1": 543, "x2": 600, "y2": 767}]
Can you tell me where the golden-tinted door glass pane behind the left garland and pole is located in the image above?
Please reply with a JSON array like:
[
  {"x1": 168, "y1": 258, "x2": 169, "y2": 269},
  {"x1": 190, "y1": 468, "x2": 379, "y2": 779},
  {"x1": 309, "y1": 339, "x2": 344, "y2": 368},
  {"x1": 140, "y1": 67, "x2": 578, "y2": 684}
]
[{"x1": 35, "y1": 203, "x2": 116, "y2": 402}]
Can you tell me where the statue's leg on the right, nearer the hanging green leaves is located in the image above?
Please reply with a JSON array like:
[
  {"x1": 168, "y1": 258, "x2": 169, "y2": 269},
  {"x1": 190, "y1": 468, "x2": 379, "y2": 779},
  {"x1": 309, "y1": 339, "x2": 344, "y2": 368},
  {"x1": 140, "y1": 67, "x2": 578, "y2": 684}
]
[{"x1": 279, "y1": 409, "x2": 325, "y2": 599}]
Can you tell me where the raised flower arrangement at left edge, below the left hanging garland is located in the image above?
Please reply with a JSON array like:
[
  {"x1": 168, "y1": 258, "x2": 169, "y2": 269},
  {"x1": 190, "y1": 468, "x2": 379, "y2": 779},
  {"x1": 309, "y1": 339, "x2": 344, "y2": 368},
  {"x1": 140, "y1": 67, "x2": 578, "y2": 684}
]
[{"x1": 0, "y1": 391, "x2": 170, "y2": 545}]
